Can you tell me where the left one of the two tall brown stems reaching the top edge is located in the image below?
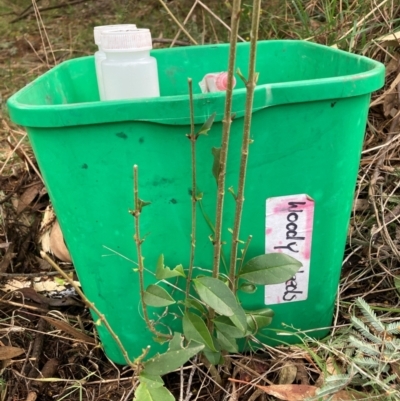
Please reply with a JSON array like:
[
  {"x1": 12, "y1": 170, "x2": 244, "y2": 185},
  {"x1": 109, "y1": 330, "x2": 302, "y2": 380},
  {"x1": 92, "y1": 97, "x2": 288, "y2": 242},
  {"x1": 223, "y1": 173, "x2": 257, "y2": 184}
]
[{"x1": 213, "y1": 0, "x2": 241, "y2": 278}]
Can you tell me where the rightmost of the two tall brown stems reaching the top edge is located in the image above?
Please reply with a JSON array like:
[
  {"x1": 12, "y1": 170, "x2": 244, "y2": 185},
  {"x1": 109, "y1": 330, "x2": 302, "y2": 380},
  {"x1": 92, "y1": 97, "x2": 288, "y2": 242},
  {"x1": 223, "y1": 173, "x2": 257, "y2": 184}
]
[{"x1": 229, "y1": 0, "x2": 261, "y2": 293}]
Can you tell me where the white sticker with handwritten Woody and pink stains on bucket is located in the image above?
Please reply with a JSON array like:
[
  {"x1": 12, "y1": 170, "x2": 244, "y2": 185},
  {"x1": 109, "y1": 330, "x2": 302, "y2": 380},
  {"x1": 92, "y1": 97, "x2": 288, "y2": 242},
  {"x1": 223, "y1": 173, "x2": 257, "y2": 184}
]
[{"x1": 265, "y1": 194, "x2": 314, "y2": 305}]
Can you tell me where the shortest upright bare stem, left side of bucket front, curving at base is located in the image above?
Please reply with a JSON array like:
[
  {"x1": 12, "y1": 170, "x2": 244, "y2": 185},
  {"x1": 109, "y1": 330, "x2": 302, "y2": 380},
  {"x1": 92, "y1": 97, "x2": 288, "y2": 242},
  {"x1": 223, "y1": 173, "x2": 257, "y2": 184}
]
[{"x1": 131, "y1": 165, "x2": 171, "y2": 338}]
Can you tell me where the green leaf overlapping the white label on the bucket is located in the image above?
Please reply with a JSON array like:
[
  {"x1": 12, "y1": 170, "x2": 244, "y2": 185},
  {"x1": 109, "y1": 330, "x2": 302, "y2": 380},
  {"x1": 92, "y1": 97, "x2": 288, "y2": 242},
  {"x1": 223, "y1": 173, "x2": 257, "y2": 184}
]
[{"x1": 239, "y1": 253, "x2": 303, "y2": 285}]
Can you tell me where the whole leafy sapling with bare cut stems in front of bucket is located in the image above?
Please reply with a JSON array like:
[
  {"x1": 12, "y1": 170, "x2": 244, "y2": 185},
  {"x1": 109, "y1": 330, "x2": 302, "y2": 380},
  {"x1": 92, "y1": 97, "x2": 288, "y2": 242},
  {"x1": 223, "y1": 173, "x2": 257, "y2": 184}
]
[{"x1": 42, "y1": 0, "x2": 301, "y2": 401}]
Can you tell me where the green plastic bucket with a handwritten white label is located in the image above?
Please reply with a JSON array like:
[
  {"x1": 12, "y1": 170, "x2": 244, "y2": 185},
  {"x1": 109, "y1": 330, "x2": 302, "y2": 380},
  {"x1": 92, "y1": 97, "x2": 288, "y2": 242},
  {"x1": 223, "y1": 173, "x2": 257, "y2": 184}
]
[{"x1": 8, "y1": 41, "x2": 384, "y2": 363}]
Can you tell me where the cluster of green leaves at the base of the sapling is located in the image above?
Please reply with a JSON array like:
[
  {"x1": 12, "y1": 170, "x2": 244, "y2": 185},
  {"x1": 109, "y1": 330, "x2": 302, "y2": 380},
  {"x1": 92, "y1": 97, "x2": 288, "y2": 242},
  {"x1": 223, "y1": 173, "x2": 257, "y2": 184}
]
[{"x1": 135, "y1": 253, "x2": 301, "y2": 401}]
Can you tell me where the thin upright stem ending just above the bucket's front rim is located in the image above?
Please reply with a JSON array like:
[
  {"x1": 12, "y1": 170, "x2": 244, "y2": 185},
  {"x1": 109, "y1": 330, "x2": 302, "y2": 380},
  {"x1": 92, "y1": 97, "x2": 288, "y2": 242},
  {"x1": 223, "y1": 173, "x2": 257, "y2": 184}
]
[{"x1": 185, "y1": 78, "x2": 197, "y2": 310}]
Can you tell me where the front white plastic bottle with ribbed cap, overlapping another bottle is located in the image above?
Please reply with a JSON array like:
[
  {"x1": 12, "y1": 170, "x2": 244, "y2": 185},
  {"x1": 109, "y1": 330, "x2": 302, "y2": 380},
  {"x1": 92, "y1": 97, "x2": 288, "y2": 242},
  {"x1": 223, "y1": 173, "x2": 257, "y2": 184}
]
[{"x1": 101, "y1": 29, "x2": 160, "y2": 100}]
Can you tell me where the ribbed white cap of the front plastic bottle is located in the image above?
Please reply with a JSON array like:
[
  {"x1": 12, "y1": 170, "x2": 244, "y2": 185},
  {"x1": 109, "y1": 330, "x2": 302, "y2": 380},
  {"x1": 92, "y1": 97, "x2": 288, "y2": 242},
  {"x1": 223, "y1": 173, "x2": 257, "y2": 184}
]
[{"x1": 101, "y1": 29, "x2": 153, "y2": 52}]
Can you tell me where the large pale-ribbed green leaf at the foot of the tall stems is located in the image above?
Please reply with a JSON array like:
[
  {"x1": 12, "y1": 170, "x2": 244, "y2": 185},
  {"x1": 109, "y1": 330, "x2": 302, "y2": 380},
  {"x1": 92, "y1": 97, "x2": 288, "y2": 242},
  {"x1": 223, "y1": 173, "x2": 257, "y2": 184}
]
[{"x1": 193, "y1": 277, "x2": 239, "y2": 316}]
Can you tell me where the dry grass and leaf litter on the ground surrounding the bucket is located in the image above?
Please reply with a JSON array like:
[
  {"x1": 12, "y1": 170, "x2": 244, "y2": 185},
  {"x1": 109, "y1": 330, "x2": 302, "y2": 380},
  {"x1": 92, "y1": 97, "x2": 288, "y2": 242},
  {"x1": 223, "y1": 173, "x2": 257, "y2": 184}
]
[{"x1": 0, "y1": 0, "x2": 400, "y2": 401}]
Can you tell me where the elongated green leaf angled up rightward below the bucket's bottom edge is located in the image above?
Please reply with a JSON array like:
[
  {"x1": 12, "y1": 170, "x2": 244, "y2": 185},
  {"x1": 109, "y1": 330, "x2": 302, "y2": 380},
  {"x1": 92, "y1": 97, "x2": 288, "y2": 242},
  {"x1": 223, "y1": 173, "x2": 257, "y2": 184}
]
[{"x1": 144, "y1": 343, "x2": 204, "y2": 376}]
